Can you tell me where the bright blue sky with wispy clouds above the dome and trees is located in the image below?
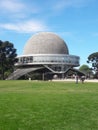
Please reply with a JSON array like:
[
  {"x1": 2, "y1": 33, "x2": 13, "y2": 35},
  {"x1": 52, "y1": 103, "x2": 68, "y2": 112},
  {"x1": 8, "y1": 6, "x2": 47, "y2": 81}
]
[{"x1": 0, "y1": 0, "x2": 98, "y2": 65}]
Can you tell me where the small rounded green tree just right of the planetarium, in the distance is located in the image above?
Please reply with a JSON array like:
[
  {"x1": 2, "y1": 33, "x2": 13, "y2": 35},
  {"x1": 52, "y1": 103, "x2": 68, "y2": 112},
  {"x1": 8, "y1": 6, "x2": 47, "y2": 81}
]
[{"x1": 79, "y1": 65, "x2": 93, "y2": 78}]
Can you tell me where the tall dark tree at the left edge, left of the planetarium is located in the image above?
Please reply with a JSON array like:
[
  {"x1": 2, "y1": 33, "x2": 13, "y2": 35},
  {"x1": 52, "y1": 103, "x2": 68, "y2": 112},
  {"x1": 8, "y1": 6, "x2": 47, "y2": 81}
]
[{"x1": 0, "y1": 40, "x2": 17, "y2": 79}]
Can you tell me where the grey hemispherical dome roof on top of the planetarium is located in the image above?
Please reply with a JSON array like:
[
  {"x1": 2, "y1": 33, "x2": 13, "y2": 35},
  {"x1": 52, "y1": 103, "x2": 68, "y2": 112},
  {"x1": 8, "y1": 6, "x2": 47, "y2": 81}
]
[{"x1": 23, "y1": 32, "x2": 69, "y2": 55}]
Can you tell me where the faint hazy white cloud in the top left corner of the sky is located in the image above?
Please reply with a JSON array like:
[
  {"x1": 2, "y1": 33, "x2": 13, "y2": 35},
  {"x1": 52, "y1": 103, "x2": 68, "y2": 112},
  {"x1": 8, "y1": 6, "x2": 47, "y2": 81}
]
[{"x1": 0, "y1": 0, "x2": 41, "y2": 14}]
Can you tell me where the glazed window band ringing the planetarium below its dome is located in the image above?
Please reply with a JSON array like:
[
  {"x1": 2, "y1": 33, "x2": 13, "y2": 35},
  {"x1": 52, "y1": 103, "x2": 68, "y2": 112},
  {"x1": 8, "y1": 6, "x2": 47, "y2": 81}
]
[{"x1": 18, "y1": 56, "x2": 79, "y2": 64}]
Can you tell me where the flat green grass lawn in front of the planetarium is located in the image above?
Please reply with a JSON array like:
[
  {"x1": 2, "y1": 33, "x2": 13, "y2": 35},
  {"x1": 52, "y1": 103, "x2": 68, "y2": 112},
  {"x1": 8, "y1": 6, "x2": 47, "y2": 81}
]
[{"x1": 0, "y1": 81, "x2": 98, "y2": 130}]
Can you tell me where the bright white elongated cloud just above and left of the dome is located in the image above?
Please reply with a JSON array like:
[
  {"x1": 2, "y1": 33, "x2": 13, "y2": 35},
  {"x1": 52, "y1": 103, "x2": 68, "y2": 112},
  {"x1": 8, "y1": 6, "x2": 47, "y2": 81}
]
[{"x1": 0, "y1": 20, "x2": 47, "y2": 33}]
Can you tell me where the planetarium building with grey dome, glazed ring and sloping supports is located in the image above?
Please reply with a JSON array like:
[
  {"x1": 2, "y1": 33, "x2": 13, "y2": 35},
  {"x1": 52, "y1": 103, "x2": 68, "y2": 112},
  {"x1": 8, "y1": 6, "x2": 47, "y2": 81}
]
[{"x1": 9, "y1": 32, "x2": 80, "y2": 79}]
